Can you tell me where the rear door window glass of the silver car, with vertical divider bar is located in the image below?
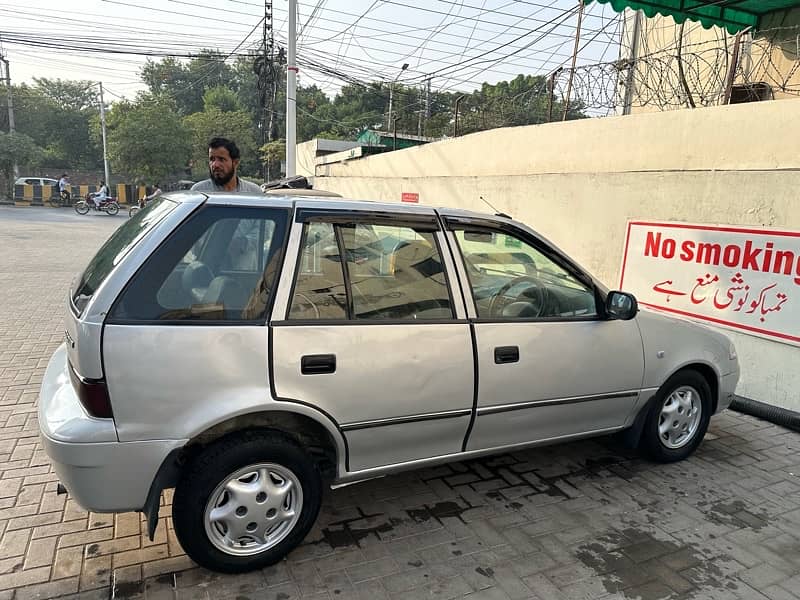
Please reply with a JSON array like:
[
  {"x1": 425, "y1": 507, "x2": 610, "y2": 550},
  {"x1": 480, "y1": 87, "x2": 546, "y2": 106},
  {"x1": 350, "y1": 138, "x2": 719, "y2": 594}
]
[{"x1": 289, "y1": 222, "x2": 453, "y2": 321}]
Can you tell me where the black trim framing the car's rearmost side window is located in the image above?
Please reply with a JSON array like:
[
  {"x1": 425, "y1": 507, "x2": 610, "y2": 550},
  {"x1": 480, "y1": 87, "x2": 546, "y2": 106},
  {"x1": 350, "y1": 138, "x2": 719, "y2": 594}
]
[{"x1": 103, "y1": 204, "x2": 292, "y2": 327}]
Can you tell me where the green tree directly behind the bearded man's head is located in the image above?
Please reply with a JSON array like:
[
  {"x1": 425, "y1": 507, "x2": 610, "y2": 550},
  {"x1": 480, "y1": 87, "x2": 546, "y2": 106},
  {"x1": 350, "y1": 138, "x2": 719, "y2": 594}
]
[{"x1": 183, "y1": 107, "x2": 261, "y2": 178}]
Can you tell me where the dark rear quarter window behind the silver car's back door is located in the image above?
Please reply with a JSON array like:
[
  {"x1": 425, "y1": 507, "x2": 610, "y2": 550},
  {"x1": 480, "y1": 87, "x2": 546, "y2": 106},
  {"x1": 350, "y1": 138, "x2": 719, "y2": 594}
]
[{"x1": 110, "y1": 206, "x2": 288, "y2": 322}]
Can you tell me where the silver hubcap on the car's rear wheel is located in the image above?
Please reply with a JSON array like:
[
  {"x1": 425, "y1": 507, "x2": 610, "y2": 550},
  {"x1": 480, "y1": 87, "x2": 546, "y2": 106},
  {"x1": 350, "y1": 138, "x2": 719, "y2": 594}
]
[{"x1": 203, "y1": 463, "x2": 303, "y2": 556}]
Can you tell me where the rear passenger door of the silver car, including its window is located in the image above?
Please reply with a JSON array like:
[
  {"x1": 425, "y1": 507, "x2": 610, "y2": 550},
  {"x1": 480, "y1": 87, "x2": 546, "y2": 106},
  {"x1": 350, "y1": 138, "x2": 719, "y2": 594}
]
[{"x1": 271, "y1": 210, "x2": 474, "y2": 471}]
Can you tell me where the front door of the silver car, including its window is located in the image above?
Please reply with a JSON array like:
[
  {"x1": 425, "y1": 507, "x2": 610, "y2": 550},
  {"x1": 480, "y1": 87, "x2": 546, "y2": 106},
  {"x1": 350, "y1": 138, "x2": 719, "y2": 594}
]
[{"x1": 447, "y1": 219, "x2": 644, "y2": 450}]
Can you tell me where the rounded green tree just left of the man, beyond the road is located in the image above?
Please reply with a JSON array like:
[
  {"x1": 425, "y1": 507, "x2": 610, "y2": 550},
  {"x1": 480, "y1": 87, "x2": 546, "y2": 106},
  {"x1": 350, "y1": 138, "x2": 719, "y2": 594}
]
[{"x1": 107, "y1": 94, "x2": 191, "y2": 181}]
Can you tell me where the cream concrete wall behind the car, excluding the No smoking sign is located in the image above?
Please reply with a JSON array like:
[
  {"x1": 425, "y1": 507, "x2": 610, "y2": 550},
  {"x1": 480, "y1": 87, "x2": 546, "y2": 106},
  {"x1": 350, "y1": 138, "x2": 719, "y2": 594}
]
[{"x1": 315, "y1": 102, "x2": 800, "y2": 418}]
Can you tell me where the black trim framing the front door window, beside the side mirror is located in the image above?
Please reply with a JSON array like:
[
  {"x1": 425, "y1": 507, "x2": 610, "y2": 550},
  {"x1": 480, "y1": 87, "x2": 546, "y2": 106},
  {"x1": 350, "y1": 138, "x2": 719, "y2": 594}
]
[{"x1": 443, "y1": 215, "x2": 606, "y2": 323}]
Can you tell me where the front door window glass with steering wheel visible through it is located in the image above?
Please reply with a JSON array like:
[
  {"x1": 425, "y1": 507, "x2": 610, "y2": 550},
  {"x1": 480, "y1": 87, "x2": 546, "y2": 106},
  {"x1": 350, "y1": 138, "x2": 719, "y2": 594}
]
[{"x1": 455, "y1": 228, "x2": 598, "y2": 320}]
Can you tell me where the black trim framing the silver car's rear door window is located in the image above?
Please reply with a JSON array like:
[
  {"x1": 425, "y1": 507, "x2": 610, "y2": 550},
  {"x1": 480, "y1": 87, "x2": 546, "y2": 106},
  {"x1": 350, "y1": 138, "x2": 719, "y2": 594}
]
[{"x1": 288, "y1": 214, "x2": 465, "y2": 325}]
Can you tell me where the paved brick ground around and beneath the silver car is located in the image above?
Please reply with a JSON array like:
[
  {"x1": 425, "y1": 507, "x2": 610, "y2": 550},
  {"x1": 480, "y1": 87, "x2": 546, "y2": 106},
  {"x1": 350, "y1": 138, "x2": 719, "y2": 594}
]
[{"x1": 0, "y1": 207, "x2": 800, "y2": 600}]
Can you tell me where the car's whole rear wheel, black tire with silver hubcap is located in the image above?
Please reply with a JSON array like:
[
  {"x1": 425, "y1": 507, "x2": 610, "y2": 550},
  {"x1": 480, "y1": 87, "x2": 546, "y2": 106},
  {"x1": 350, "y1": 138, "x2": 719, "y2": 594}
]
[{"x1": 172, "y1": 430, "x2": 322, "y2": 573}]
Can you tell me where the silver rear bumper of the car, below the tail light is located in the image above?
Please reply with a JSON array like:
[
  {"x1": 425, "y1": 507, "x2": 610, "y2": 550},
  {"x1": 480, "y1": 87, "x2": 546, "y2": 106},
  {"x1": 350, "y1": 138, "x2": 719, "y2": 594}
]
[{"x1": 38, "y1": 345, "x2": 186, "y2": 512}]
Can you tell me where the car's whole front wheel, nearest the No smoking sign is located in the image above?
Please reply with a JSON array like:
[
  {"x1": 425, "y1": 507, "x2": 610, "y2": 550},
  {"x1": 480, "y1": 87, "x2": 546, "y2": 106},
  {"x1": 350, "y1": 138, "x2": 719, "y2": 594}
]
[{"x1": 641, "y1": 370, "x2": 711, "y2": 463}]
